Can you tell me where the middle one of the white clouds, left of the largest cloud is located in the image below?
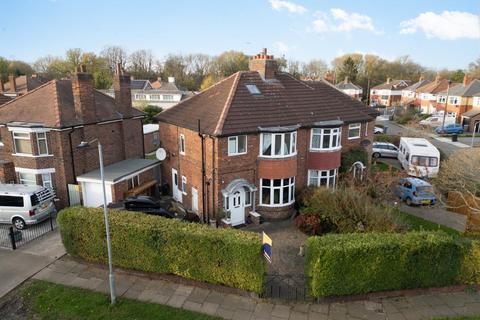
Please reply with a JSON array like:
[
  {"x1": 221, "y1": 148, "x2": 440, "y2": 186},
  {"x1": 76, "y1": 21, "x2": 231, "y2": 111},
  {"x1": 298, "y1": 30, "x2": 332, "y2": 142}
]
[{"x1": 312, "y1": 8, "x2": 382, "y2": 34}]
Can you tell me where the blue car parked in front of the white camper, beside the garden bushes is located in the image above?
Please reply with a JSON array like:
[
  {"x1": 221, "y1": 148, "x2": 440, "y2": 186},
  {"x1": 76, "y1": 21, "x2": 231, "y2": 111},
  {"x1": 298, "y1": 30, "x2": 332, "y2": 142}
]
[{"x1": 395, "y1": 178, "x2": 437, "y2": 206}]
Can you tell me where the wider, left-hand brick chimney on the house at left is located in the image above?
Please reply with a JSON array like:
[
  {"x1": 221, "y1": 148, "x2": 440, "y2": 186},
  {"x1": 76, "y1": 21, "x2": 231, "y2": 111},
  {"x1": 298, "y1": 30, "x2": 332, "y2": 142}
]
[{"x1": 72, "y1": 64, "x2": 97, "y2": 123}]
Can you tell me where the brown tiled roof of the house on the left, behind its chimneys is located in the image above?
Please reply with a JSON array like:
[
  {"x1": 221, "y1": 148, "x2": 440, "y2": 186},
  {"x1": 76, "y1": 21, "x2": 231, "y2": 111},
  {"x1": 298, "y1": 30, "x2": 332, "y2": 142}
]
[{"x1": 0, "y1": 80, "x2": 144, "y2": 128}]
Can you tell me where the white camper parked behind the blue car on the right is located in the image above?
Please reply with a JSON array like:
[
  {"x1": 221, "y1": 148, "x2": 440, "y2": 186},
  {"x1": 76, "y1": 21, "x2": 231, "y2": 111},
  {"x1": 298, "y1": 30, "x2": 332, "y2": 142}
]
[{"x1": 398, "y1": 137, "x2": 440, "y2": 178}]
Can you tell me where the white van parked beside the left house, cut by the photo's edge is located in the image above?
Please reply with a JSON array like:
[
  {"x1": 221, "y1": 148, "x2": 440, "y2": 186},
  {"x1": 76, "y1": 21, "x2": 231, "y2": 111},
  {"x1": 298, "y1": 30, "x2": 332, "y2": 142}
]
[{"x1": 0, "y1": 184, "x2": 56, "y2": 230}]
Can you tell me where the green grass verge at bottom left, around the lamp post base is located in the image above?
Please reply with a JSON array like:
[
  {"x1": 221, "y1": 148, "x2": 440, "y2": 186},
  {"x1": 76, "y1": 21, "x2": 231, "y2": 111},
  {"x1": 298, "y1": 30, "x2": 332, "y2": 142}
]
[{"x1": 21, "y1": 280, "x2": 218, "y2": 320}]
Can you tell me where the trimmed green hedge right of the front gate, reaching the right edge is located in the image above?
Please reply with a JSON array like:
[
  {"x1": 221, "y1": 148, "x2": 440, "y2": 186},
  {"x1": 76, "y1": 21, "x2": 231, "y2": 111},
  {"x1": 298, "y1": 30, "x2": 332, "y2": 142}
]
[{"x1": 305, "y1": 232, "x2": 480, "y2": 297}]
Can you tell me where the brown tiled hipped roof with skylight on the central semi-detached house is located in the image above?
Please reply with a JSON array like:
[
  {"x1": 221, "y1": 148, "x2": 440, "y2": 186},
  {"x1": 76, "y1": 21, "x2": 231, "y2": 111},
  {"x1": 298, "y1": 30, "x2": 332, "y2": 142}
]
[{"x1": 157, "y1": 71, "x2": 376, "y2": 136}]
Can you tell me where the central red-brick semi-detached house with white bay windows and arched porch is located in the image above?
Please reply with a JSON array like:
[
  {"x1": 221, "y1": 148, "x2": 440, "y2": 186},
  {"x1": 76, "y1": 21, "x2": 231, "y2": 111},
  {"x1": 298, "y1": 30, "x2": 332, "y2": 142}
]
[{"x1": 157, "y1": 49, "x2": 377, "y2": 225}]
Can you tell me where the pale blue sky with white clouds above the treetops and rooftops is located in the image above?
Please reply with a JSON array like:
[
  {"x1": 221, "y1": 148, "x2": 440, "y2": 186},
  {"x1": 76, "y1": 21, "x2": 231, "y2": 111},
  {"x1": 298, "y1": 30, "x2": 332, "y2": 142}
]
[{"x1": 0, "y1": 0, "x2": 480, "y2": 69}]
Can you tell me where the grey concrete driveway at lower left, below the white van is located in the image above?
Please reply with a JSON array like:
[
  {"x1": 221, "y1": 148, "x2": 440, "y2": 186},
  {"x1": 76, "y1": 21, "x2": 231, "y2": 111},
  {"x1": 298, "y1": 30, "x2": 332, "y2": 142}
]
[{"x1": 0, "y1": 230, "x2": 65, "y2": 298}]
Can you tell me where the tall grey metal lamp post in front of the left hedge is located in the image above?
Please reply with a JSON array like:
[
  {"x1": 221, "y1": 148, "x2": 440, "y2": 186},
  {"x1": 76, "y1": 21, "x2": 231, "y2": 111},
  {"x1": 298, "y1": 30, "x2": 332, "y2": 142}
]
[{"x1": 77, "y1": 139, "x2": 116, "y2": 305}]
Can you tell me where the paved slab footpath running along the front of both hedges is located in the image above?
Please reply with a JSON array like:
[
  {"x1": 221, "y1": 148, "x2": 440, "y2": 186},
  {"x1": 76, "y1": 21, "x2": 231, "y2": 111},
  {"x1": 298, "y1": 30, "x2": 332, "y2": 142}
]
[{"x1": 34, "y1": 256, "x2": 480, "y2": 320}]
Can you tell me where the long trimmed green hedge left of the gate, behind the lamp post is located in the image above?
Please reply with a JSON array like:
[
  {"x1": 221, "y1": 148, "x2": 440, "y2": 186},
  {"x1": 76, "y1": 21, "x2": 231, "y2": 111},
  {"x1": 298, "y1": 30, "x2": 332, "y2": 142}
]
[{"x1": 58, "y1": 207, "x2": 266, "y2": 293}]
